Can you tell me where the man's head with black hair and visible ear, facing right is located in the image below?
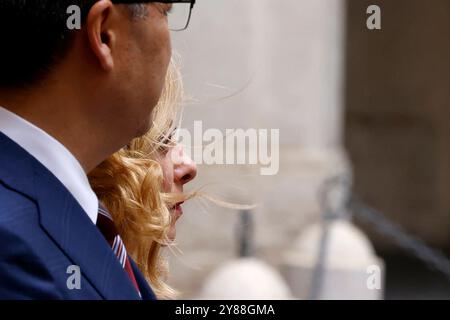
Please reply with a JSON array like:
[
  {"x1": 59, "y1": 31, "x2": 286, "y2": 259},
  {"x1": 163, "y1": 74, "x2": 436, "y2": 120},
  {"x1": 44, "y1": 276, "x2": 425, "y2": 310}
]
[{"x1": 0, "y1": 0, "x2": 171, "y2": 160}]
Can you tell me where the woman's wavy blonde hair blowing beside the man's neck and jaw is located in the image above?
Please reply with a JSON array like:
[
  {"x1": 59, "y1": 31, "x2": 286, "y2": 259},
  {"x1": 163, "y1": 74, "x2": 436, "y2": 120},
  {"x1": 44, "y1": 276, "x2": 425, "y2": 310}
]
[{"x1": 89, "y1": 60, "x2": 183, "y2": 299}]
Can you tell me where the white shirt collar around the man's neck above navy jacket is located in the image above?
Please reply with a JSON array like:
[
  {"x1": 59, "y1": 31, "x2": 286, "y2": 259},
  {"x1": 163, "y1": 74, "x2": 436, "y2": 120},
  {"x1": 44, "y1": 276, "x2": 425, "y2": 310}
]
[{"x1": 0, "y1": 107, "x2": 98, "y2": 224}]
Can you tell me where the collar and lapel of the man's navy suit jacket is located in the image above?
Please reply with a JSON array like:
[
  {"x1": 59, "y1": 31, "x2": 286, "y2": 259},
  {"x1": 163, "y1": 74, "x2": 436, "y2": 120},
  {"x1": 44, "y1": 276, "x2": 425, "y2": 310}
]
[{"x1": 0, "y1": 132, "x2": 144, "y2": 300}]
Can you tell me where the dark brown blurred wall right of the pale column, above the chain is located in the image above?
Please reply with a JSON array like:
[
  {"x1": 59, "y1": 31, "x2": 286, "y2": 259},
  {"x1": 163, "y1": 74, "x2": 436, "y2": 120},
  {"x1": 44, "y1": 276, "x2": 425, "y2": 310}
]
[{"x1": 345, "y1": 0, "x2": 450, "y2": 252}]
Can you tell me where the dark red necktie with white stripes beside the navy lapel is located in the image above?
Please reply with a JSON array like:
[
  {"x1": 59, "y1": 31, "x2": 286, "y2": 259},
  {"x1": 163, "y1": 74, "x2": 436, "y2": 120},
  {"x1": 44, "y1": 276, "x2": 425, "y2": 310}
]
[{"x1": 97, "y1": 204, "x2": 141, "y2": 296}]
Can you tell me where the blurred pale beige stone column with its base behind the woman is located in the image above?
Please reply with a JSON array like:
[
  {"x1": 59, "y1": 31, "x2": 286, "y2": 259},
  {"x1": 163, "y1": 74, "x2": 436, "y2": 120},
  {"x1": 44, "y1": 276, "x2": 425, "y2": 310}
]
[{"x1": 171, "y1": 0, "x2": 347, "y2": 297}]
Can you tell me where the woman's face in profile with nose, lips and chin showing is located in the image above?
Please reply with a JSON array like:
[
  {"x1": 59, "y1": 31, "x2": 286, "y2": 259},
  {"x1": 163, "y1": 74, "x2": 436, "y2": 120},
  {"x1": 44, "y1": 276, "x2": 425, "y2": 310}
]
[{"x1": 157, "y1": 144, "x2": 197, "y2": 240}]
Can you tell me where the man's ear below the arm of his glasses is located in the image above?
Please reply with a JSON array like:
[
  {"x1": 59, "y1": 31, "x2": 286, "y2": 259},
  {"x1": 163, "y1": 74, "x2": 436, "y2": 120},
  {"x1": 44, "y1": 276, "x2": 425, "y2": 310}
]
[{"x1": 85, "y1": 0, "x2": 116, "y2": 71}]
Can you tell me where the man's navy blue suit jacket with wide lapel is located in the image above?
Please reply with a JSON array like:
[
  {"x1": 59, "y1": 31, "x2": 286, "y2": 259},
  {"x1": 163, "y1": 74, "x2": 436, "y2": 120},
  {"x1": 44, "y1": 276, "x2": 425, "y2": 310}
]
[{"x1": 0, "y1": 132, "x2": 155, "y2": 300}]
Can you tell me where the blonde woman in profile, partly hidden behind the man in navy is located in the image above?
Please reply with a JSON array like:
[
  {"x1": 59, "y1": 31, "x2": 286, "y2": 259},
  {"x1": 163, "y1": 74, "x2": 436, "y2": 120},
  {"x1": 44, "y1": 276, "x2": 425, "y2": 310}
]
[{"x1": 89, "y1": 58, "x2": 197, "y2": 298}]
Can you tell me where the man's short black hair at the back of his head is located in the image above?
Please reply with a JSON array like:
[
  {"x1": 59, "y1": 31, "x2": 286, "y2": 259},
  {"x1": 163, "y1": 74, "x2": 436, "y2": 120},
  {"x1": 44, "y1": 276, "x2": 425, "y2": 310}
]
[{"x1": 0, "y1": 0, "x2": 146, "y2": 88}]
